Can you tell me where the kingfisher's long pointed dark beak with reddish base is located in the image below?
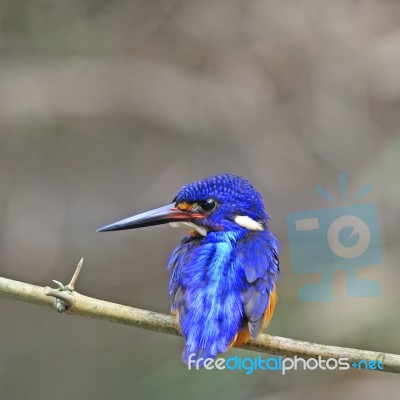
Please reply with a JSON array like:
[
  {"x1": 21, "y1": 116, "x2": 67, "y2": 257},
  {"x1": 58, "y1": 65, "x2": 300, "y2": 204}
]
[{"x1": 97, "y1": 203, "x2": 204, "y2": 232}]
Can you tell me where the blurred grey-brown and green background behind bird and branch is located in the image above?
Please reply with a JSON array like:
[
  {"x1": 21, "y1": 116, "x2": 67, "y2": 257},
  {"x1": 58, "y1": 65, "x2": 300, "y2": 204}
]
[{"x1": 0, "y1": 0, "x2": 400, "y2": 400}]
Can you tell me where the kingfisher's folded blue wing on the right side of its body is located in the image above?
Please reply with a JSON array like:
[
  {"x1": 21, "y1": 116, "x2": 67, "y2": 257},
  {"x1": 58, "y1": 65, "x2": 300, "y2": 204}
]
[{"x1": 237, "y1": 230, "x2": 280, "y2": 338}]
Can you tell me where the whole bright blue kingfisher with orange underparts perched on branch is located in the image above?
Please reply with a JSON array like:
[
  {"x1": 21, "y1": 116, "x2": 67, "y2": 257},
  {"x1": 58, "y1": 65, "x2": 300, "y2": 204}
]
[{"x1": 98, "y1": 174, "x2": 280, "y2": 366}]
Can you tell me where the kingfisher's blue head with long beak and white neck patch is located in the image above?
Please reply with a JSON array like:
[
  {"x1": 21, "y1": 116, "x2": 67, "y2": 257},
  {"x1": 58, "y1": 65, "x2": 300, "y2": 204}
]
[{"x1": 98, "y1": 174, "x2": 268, "y2": 236}]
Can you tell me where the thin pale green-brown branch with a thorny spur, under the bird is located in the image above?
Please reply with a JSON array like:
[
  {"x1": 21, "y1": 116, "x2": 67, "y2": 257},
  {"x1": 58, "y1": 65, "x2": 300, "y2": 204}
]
[{"x1": 0, "y1": 260, "x2": 400, "y2": 373}]
